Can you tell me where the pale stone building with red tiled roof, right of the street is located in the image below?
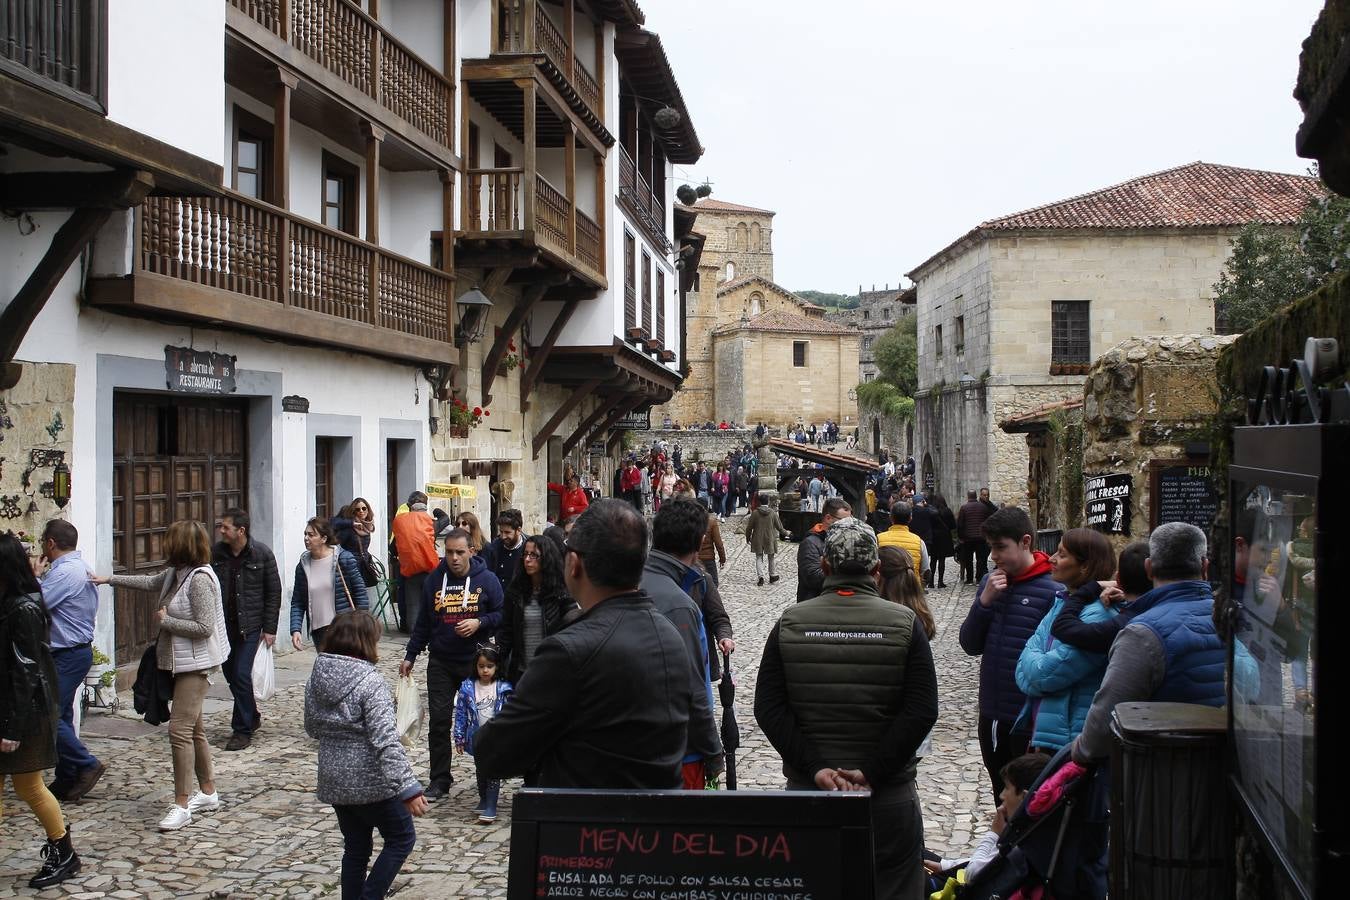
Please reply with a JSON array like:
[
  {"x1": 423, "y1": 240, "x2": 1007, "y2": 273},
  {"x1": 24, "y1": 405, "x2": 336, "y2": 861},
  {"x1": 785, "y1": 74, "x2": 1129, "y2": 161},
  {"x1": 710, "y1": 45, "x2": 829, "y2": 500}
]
[{"x1": 909, "y1": 162, "x2": 1322, "y2": 503}]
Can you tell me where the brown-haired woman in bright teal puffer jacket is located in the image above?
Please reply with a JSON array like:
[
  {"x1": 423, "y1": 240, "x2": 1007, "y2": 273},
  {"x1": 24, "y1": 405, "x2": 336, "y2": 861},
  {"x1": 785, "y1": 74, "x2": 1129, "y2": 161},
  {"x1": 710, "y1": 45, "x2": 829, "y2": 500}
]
[{"x1": 1014, "y1": 528, "x2": 1116, "y2": 754}]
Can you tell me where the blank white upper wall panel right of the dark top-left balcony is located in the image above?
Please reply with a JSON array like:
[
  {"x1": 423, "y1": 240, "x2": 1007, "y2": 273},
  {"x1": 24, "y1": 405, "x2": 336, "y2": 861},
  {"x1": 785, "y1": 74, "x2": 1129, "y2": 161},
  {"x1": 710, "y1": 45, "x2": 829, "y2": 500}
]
[{"x1": 108, "y1": 0, "x2": 228, "y2": 165}]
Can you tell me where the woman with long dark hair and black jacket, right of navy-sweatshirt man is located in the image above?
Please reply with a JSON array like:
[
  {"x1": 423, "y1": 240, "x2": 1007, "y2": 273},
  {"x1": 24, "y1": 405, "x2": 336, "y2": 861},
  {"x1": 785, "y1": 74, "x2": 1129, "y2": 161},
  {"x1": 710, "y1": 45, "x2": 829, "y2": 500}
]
[{"x1": 497, "y1": 534, "x2": 576, "y2": 684}]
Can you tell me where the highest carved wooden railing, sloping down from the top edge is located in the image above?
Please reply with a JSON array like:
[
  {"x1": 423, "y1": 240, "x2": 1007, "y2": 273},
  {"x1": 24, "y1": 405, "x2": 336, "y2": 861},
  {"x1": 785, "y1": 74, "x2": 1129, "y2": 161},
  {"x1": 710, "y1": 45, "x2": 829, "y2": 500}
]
[{"x1": 230, "y1": 0, "x2": 454, "y2": 147}]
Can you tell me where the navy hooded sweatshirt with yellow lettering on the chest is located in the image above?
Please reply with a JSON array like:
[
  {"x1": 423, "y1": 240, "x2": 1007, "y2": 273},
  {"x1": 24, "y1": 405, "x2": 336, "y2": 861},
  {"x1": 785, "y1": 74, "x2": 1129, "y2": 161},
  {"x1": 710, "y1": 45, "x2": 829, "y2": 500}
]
[{"x1": 404, "y1": 556, "x2": 502, "y2": 671}]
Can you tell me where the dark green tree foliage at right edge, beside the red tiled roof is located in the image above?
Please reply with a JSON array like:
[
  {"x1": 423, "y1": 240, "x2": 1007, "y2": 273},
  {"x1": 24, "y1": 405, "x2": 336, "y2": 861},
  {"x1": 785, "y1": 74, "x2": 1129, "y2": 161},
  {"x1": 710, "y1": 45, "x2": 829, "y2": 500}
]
[{"x1": 1214, "y1": 184, "x2": 1350, "y2": 332}]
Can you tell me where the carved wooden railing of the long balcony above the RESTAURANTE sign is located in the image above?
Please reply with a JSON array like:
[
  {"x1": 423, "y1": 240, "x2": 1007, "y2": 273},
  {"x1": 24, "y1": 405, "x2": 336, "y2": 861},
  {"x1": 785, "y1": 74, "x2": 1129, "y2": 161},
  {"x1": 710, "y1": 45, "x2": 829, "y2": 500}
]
[{"x1": 135, "y1": 193, "x2": 452, "y2": 343}]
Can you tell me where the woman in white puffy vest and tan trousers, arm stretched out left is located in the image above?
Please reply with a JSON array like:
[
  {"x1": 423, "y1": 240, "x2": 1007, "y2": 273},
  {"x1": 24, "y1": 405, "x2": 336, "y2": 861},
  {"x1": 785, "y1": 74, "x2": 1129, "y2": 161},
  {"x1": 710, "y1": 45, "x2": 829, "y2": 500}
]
[{"x1": 93, "y1": 519, "x2": 230, "y2": 831}]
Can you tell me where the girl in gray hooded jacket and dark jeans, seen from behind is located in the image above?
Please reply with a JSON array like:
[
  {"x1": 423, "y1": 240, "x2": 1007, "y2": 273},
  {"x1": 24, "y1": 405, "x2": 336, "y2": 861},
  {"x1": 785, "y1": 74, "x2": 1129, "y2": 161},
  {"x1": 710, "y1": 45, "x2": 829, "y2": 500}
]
[{"x1": 305, "y1": 610, "x2": 427, "y2": 900}]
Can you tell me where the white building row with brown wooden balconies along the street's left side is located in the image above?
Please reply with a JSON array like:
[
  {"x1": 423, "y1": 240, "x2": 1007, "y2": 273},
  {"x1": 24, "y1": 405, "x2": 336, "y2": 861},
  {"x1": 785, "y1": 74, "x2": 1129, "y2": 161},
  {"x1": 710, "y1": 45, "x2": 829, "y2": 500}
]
[{"x1": 0, "y1": 0, "x2": 702, "y2": 665}]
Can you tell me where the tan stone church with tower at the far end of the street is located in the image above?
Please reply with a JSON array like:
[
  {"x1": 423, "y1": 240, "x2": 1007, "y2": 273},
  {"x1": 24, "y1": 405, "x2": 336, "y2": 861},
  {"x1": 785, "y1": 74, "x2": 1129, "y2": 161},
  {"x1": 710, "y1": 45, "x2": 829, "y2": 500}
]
[{"x1": 652, "y1": 200, "x2": 861, "y2": 425}]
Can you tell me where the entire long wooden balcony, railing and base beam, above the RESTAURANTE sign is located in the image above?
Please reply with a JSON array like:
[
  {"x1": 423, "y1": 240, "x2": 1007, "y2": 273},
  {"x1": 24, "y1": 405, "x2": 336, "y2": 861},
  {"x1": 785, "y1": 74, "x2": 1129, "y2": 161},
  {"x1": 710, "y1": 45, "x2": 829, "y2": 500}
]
[{"x1": 89, "y1": 192, "x2": 455, "y2": 364}]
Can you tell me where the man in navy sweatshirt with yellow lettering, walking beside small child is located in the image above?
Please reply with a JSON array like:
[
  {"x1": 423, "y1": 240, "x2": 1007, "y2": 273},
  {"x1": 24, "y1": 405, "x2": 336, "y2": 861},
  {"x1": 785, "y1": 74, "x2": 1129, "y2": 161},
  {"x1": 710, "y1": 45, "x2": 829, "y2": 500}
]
[{"x1": 398, "y1": 528, "x2": 502, "y2": 800}]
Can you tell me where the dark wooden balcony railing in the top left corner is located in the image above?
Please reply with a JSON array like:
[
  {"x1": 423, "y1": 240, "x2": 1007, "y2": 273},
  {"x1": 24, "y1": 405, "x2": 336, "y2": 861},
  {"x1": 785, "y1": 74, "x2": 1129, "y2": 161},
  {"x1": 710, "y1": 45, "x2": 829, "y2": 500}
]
[{"x1": 0, "y1": 0, "x2": 108, "y2": 112}]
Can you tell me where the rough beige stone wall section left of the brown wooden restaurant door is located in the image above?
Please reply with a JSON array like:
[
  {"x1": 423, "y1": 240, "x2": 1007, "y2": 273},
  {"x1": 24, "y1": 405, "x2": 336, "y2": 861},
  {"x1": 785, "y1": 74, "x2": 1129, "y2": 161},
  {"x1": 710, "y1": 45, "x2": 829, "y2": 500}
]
[{"x1": 0, "y1": 363, "x2": 75, "y2": 538}]
